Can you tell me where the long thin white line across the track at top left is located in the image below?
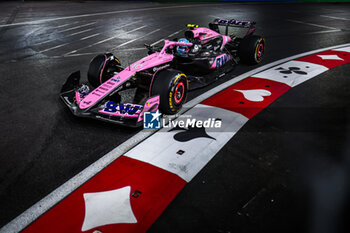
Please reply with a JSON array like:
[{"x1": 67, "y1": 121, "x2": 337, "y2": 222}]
[{"x1": 0, "y1": 4, "x2": 222, "y2": 28}]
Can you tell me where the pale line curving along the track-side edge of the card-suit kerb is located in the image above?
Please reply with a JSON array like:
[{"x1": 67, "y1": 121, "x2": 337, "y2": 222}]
[{"x1": 0, "y1": 43, "x2": 350, "y2": 233}]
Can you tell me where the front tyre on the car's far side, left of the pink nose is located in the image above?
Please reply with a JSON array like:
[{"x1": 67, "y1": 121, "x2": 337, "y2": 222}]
[{"x1": 88, "y1": 53, "x2": 122, "y2": 88}]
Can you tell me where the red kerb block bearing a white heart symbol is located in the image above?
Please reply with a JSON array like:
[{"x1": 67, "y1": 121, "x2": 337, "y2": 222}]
[{"x1": 202, "y1": 77, "x2": 291, "y2": 118}]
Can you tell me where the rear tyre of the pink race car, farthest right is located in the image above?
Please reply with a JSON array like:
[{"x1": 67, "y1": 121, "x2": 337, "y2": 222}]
[{"x1": 238, "y1": 35, "x2": 265, "y2": 65}]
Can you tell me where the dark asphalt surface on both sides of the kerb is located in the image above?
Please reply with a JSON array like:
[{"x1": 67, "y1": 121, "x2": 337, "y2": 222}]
[{"x1": 0, "y1": 2, "x2": 350, "y2": 232}]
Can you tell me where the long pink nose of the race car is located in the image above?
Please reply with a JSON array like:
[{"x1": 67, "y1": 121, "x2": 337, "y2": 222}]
[{"x1": 79, "y1": 40, "x2": 193, "y2": 109}]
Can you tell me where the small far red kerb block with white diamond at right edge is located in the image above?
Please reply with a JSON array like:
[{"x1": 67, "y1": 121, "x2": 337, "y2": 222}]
[{"x1": 296, "y1": 50, "x2": 350, "y2": 69}]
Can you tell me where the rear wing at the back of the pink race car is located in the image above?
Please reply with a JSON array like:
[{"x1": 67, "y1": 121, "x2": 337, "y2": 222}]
[{"x1": 209, "y1": 19, "x2": 256, "y2": 36}]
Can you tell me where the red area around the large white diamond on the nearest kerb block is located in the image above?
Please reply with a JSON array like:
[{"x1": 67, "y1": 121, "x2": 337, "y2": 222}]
[{"x1": 23, "y1": 156, "x2": 186, "y2": 233}]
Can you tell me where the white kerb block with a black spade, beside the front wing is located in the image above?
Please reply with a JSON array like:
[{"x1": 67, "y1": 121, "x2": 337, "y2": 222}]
[{"x1": 125, "y1": 104, "x2": 248, "y2": 182}]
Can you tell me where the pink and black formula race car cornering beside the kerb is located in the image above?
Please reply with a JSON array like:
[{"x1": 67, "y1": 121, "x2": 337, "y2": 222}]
[{"x1": 60, "y1": 19, "x2": 265, "y2": 126}]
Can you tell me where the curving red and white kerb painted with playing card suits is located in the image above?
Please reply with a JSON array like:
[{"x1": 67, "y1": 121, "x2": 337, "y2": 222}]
[{"x1": 7, "y1": 47, "x2": 350, "y2": 233}]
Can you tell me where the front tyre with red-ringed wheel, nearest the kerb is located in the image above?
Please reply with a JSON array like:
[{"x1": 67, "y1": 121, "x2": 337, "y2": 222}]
[{"x1": 151, "y1": 69, "x2": 188, "y2": 115}]
